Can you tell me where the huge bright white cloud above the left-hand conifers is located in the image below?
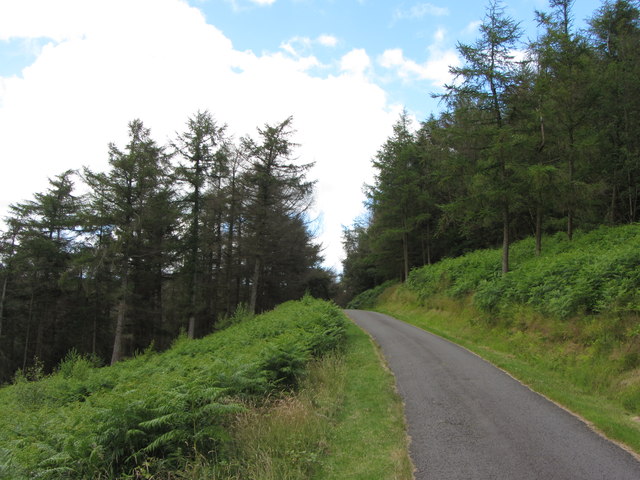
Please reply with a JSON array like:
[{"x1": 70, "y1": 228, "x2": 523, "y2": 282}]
[{"x1": 0, "y1": 0, "x2": 398, "y2": 266}]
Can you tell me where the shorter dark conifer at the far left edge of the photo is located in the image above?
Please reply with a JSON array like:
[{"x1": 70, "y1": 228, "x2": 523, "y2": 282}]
[{"x1": 2, "y1": 171, "x2": 79, "y2": 376}]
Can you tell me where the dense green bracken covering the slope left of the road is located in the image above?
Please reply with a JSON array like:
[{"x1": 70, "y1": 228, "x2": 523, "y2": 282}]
[{"x1": 0, "y1": 298, "x2": 345, "y2": 480}]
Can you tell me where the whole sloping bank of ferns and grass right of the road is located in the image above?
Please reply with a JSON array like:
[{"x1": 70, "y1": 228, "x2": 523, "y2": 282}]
[{"x1": 356, "y1": 225, "x2": 640, "y2": 452}]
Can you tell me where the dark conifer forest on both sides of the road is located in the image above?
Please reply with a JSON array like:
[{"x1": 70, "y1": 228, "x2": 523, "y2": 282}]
[{"x1": 0, "y1": 0, "x2": 640, "y2": 383}]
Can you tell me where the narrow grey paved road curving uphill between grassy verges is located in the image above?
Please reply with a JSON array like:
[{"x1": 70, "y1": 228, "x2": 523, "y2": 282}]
[{"x1": 347, "y1": 310, "x2": 640, "y2": 480}]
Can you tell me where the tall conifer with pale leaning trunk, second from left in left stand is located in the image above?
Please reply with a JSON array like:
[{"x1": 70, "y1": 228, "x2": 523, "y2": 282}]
[{"x1": 85, "y1": 120, "x2": 175, "y2": 364}]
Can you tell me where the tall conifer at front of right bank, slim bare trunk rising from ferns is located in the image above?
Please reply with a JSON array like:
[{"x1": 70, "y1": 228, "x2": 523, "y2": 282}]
[{"x1": 444, "y1": 0, "x2": 521, "y2": 273}]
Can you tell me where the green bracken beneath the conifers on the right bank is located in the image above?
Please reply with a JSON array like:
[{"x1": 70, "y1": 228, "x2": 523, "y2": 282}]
[{"x1": 407, "y1": 224, "x2": 640, "y2": 319}]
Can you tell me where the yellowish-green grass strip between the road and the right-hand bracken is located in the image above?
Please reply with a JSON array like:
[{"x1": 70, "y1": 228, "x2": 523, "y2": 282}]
[{"x1": 375, "y1": 287, "x2": 640, "y2": 454}]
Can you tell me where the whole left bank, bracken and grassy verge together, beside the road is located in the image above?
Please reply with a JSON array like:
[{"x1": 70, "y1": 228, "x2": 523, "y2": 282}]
[{"x1": 0, "y1": 298, "x2": 410, "y2": 480}]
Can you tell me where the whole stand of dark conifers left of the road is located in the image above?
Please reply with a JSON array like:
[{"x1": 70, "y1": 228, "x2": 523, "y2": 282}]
[{"x1": 0, "y1": 112, "x2": 333, "y2": 382}]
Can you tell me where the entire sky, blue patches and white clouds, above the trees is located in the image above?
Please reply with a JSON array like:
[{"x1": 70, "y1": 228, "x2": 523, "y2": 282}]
[{"x1": 0, "y1": 0, "x2": 601, "y2": 271}]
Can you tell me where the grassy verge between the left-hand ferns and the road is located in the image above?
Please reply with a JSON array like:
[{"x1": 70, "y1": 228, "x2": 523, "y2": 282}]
[{"x1": 194, "y1": 318, "x2": 413, "y2": 480}]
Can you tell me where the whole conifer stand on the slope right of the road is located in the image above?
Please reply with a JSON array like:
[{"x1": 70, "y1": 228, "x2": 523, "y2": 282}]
[{"x1": 343, "y1": 0, "x2": 640, "y2": 295}]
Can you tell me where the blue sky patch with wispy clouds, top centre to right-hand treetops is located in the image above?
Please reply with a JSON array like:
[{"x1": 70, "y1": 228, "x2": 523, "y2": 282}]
[{"x1": 190, "y1": 0, "x2": 600, "y2": 119}]
